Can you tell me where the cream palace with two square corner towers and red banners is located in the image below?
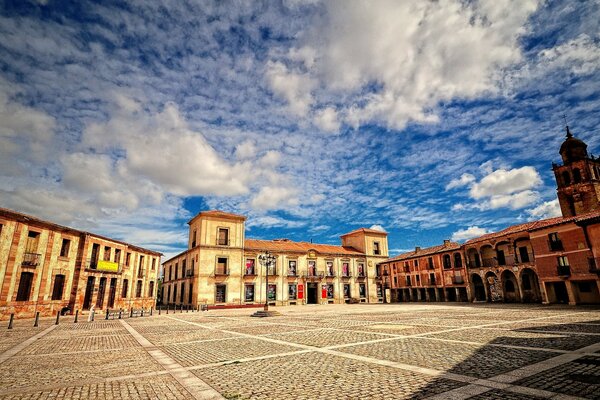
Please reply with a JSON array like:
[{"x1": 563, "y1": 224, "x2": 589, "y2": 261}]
[{"x1": 162, "y1": 210, "x2": 389, "y2": 307}]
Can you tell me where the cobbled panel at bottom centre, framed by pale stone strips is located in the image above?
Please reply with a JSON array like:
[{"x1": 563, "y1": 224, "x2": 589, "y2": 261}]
[{"x1": 194, "y1": 353, "x2": 463, "y2": 400}]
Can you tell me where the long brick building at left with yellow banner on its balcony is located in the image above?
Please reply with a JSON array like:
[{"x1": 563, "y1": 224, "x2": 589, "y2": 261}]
[{"x1": 0, "y1": 208, "x2": 161, "y2": 318}]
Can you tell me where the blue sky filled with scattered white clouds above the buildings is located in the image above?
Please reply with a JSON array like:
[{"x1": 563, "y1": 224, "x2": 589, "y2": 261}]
[{"x1": 0, "y1": 0, "x2": 600, "y2": 256}]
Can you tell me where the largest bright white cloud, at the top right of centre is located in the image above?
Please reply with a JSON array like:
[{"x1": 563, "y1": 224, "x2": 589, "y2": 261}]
[{"x1": 267, "y1": 0, "x2": 537, "y2": 129}]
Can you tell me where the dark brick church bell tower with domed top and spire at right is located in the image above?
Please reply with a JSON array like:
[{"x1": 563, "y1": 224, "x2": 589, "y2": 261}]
[{"x1": 552, "y1": 126, "x2": 600, "y2": 217}]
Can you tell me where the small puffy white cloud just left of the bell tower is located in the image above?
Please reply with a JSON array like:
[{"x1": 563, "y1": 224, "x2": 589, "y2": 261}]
[{"x1": 469, "y1": 167, "x2": 542, "y2": 199}]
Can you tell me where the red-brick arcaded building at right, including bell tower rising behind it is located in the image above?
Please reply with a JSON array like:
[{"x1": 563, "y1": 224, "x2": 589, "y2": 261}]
[{"x1": 380, "y1": 127, "x2": 600, "y2": 304}]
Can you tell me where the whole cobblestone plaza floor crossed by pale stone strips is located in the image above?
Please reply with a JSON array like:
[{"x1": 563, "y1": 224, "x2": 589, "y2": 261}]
[{"x1": 0, "y1": 303, "x2": 600, "y2": 400}]
